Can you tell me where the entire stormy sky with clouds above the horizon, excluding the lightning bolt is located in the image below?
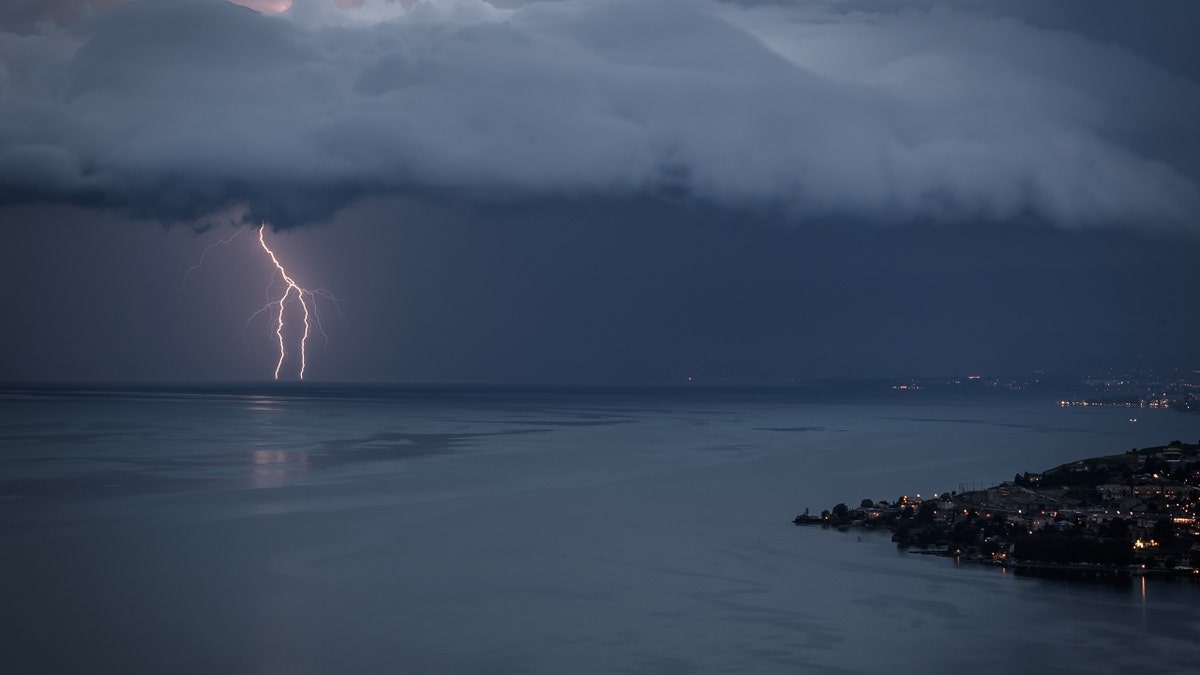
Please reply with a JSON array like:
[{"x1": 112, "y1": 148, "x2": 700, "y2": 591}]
[{"x1": 0, "y1": 0, "x2": 1200, "y2": 382}]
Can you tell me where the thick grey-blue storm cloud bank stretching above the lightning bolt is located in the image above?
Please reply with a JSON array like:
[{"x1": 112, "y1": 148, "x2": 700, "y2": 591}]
[{"x1": 0, "y1": 0, "x2": 1200, "y2": 229}]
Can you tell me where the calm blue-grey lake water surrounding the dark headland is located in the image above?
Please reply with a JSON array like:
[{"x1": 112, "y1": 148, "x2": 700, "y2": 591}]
[{"x1": 0, "y1": 388, "x2": 1200, "y2": 674}]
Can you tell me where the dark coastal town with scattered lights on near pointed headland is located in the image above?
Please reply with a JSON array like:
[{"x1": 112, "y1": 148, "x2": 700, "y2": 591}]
[{"x1": 793, "y1": 441, "x2": 1200, "y2": 579}]
